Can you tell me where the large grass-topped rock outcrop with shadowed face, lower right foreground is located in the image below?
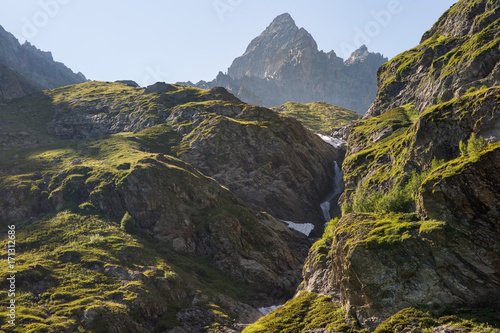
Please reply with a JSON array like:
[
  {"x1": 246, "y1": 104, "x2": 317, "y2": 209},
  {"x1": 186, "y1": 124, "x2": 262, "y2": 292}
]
[{"x1": 302, "y1": 210, "x2": 500, "y2": 330}]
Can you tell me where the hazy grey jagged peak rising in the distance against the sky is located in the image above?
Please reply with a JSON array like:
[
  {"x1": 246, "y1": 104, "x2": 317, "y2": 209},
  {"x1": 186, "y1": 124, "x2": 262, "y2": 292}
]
[{"x1": 181, "y1": 14, "x2": 387, "y2": 113}]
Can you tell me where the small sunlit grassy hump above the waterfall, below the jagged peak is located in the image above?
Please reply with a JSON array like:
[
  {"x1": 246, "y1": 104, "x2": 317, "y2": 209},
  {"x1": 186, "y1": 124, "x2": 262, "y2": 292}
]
[{"x1": 273, "y1": 102, "x2": 361, "y2": 132}]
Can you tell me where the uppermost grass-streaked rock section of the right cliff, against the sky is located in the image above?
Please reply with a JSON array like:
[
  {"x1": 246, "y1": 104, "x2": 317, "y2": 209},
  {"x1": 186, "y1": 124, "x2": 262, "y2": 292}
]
[{"x1": 366, "y1": 0, "x2": 500, "y2": 117}]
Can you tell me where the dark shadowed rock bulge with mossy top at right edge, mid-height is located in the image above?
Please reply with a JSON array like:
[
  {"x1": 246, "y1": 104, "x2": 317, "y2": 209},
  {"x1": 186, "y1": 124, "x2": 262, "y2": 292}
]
[{"x1": 419, "y1": 145, "x2": 500, "y2": 233}]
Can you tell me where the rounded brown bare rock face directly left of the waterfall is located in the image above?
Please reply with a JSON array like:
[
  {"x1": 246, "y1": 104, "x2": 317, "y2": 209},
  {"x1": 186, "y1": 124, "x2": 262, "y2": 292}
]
[{"x1": 181, "y1": 108, "x2": 341, "y2": 230}]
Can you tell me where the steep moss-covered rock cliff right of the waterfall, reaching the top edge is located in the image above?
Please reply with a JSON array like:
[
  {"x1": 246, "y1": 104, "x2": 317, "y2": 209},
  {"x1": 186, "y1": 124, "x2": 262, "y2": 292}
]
[{"x1": 249, "y1": 0, "x2": 500, "y2": 332}]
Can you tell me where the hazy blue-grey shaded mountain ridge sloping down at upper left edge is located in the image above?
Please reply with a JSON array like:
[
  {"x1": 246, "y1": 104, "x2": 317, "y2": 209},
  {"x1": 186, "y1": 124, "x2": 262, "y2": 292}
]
[{"x1": 0, "y1": 26, "x2": 86, "y2": 90}]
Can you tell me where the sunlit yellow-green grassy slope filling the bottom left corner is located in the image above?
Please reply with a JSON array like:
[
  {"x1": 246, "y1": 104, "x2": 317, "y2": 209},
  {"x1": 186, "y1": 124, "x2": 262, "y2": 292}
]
[{"x1": 0, "y1": 211, "x2": 252, "y2": 332}]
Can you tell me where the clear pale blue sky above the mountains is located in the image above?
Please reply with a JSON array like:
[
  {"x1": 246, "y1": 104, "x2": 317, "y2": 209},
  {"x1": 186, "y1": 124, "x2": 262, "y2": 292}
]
[{"x1": 0, "y1": 0, "x2": 456, "y2": 85}]
